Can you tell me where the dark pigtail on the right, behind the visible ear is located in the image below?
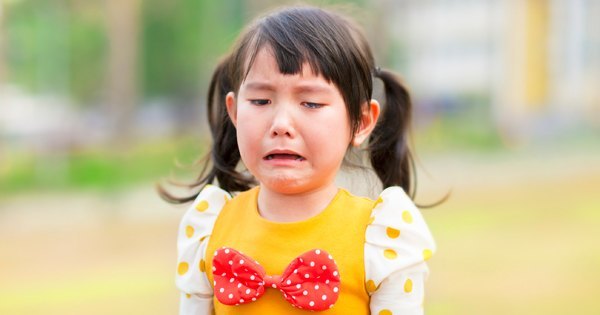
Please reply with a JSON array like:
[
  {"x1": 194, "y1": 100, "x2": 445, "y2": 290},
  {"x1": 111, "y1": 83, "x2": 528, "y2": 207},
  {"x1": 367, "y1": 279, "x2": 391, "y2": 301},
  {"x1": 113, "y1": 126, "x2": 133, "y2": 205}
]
[{"x1": 368, "y1": 68, "x2": 414, "y2": 197}]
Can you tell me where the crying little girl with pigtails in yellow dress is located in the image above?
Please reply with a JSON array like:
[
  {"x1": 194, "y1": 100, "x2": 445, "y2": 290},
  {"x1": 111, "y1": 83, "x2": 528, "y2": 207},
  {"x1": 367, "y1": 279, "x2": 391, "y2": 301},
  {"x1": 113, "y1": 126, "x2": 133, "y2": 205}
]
[{"x1": 161, "y1": 7, "x2": 435, "y2": 315}]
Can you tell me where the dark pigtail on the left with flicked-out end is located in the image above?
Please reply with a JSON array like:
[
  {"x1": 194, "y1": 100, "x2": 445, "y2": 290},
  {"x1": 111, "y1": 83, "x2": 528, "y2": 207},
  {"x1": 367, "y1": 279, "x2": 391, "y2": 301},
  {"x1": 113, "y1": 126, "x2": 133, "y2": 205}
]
[{"x1": 157, "y1": 58, "x2": 255, "y2": 203}]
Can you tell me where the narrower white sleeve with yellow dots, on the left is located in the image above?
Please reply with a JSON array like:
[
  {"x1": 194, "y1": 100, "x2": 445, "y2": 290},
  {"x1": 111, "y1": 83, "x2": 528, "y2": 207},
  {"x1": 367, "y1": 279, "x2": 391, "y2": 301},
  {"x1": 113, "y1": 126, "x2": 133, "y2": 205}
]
[{"x1": 175, "y1": 185, "x2": 231, "y2": 315}]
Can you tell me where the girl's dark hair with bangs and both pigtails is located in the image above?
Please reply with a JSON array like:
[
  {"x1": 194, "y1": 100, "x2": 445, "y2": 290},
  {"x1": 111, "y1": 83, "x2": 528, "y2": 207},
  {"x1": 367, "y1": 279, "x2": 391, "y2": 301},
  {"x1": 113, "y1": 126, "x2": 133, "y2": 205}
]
[{"x1": 158, "y1": 7, "x2": 414, "y2": 203}]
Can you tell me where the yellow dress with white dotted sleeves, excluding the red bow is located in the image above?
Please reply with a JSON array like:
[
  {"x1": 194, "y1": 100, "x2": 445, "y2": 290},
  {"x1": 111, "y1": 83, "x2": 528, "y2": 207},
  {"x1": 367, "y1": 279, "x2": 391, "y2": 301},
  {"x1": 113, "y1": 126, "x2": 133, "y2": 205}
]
[{"x1": 177, "y1": 186, "x2": 435, "y2": 315}]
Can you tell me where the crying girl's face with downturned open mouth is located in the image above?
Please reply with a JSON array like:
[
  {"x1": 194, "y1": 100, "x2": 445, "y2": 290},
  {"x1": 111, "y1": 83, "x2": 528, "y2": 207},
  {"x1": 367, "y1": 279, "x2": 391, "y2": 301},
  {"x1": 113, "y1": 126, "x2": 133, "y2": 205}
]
[{"x1": 226, "y1": 49, "x2": 352, "y2": 194}]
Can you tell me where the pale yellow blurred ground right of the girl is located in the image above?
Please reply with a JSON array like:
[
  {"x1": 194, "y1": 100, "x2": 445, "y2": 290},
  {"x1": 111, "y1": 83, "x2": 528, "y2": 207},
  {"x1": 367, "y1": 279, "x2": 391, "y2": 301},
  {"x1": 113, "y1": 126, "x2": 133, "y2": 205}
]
[{"x1": 426, "y1": 152, "x2": 600, "y2": 315}]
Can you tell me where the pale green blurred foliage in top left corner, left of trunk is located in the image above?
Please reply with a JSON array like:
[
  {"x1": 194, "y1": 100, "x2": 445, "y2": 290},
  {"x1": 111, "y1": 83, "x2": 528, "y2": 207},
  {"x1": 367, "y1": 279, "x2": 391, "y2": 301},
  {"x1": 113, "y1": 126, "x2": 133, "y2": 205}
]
[{"x1": 5, "y1": 0, "x2": 108, "y2": 103}]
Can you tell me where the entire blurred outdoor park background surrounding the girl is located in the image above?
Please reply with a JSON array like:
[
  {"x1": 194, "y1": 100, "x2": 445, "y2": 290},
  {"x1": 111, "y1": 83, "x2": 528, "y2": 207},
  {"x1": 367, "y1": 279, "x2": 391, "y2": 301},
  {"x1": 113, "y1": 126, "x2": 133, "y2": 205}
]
[{"x1": 0, "y1": 0, "x2": 600, "y2": 315}]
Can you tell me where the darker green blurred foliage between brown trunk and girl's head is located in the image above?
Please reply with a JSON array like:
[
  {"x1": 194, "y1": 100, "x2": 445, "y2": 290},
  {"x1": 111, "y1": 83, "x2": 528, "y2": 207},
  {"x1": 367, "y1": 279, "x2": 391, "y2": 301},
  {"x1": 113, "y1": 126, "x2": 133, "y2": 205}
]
[{"x1": 142, "y1": 0, "x2": 244, "y2": 104}]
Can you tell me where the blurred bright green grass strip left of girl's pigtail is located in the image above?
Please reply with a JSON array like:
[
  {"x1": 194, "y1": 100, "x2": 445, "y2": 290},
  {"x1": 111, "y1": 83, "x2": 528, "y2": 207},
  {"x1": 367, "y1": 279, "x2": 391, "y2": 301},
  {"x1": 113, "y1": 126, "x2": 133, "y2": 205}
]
[{"x1": 0, "y1": 138, "x2": 205, "y2": 197}]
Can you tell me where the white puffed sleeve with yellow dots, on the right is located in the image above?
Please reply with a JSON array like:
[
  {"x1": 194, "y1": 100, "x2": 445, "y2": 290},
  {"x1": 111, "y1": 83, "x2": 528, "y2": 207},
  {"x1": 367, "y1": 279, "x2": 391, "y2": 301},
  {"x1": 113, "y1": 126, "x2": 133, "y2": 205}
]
[{"x1": 365, "y1": 187, "x2": 435, "y2": 315}]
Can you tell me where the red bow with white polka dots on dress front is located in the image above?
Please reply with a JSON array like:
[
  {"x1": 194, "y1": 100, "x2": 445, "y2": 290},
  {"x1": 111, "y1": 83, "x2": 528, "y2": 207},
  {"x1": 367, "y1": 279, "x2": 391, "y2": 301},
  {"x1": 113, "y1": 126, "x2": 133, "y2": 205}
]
[{"x1": 213, "y1": 247, "x2": 340, "y2": 311}]
